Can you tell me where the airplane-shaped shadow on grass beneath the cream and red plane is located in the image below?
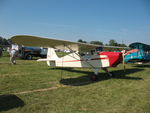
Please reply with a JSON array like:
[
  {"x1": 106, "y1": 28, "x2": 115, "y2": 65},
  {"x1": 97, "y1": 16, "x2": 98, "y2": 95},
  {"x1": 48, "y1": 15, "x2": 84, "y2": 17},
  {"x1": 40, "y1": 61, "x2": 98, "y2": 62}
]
[{"x1": 57, "y1": 68, "x2": 144, "y2": 86}]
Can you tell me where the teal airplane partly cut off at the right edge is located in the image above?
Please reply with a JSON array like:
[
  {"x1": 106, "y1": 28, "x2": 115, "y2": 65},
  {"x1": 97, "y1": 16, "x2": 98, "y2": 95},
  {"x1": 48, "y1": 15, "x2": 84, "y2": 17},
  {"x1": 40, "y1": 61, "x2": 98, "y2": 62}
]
[{"x1": 124, "y1": 42, "x2": 150, "y2": 64}]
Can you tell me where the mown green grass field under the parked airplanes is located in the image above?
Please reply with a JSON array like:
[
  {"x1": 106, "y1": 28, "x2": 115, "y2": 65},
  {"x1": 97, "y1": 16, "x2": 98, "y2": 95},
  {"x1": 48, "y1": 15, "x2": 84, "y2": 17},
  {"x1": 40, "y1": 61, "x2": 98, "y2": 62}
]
[{"x1": 0, "y1": 56, "x2": 150, "y2": 113}]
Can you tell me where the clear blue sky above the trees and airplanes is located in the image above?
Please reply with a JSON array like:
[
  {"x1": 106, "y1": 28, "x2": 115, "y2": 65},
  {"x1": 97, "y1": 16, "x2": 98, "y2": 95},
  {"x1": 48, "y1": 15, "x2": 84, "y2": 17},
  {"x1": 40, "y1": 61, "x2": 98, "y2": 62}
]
[{"x1": 0, "y1": 0, "x2": 150, "y2": 45}]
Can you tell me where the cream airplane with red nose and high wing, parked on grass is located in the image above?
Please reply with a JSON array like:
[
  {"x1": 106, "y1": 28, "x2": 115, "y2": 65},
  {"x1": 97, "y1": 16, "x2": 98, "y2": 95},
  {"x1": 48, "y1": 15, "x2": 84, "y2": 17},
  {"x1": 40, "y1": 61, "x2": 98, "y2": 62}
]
[{"x1": 11, "y1": 35, "x2": 127, "y2": 81}]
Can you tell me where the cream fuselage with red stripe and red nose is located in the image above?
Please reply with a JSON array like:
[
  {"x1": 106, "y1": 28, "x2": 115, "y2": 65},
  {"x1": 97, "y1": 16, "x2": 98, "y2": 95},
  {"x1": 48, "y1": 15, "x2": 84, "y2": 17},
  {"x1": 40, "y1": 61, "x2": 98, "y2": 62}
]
[{"x1": 47, "y1": 49, "x2": 122, "y2": 68}]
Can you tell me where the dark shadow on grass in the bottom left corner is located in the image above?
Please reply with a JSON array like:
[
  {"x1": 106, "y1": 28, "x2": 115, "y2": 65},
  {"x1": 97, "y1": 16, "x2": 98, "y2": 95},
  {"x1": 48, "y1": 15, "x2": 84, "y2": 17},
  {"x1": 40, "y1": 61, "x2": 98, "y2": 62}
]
[{"x1": 0, "y1": 94, "x2": 25, "y2": 112}]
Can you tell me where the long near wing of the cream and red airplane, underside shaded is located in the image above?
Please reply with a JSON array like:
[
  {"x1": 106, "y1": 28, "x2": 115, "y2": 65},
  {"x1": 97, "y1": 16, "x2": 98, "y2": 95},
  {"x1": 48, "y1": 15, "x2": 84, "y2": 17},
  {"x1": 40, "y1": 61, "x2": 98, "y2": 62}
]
[{"x1": 11, "y1": 35, "x2": 100, "y2": 52}]
